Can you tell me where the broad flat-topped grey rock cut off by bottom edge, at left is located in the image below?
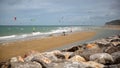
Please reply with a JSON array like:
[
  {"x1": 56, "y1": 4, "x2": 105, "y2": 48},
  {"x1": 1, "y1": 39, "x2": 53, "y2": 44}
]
[{"x1": 11, "y1": 62, "x2": 42, "y2": 68}]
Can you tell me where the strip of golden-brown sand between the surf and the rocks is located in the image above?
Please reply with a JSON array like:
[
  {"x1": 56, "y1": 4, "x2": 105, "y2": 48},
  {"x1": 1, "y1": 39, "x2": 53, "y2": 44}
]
[{"x1": 0, "y1": 32, "x2": 96, "y2": 62}]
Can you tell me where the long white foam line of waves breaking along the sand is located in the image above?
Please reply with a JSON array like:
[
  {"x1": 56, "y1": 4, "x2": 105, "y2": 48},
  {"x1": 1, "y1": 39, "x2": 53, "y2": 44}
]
[{"x1": 0, "y1": 27, "x2": 82, "y2": 41}]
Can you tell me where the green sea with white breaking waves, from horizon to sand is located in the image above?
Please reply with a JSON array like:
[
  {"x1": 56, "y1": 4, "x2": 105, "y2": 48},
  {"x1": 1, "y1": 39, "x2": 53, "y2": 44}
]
[{"x1": 0, "y1": 25, "x2": 101, "y2": 43}]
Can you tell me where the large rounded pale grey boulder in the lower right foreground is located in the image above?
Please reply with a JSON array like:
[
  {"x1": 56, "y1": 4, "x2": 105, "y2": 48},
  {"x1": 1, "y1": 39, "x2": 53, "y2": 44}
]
[{"x1": 90, "y1": 53, "x2": 113, "y2": 64}]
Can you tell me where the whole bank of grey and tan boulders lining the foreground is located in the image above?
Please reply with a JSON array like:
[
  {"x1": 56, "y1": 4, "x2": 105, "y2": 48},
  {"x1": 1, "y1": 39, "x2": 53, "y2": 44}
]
[{"x1": 0, "y1": 35, "x2": 120, "y2": 68}]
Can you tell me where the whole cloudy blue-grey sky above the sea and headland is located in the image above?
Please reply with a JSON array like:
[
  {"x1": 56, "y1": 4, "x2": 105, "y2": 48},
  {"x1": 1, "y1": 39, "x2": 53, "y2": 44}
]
[{"x1": 0, "y1": 0, "x2": 120, "y2": 25}]
